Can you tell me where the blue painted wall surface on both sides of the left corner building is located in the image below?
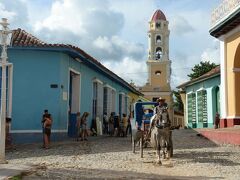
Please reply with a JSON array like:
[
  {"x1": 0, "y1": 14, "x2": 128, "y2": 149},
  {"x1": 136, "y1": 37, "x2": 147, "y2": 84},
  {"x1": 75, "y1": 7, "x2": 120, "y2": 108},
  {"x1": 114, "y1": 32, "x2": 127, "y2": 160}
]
[{"x1": 8, "y1": 49, "x2": 129, "y2": 135}]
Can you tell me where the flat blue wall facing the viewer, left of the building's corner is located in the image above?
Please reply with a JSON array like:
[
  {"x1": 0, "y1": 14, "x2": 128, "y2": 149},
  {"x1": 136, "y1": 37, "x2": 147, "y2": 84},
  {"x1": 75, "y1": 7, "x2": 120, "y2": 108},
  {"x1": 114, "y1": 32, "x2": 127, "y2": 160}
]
[{"x1": 9, "y1": 50, "x2": 66, "y2": 130}]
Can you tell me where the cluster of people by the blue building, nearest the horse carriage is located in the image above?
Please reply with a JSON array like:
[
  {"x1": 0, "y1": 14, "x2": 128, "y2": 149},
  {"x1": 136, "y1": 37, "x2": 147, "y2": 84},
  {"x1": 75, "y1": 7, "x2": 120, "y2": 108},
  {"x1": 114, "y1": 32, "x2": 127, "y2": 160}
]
[{"x1": 103, "y1": 112, "x2": 131, "y2": 137}]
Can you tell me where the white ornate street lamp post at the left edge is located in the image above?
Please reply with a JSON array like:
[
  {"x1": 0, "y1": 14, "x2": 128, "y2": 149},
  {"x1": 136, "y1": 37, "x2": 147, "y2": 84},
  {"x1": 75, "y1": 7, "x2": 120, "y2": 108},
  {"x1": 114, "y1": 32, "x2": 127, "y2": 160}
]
[{"x1": 0, "y1": 18, "x2": 11, "y2": 163}]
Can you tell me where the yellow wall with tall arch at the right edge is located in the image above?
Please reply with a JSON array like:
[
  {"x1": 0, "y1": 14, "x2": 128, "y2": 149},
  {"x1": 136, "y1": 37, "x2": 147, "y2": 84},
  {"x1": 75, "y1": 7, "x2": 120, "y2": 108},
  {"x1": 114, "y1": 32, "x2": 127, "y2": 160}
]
[{"x1": 225, "y1": 32, "x2": 240, "y2": 116}]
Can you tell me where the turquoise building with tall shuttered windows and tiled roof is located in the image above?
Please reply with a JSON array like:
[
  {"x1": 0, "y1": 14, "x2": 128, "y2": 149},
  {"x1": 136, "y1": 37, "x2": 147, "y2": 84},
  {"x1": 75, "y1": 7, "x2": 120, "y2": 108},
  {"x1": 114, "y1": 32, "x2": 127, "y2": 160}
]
[{"x1": 177, "y1": 66, "x2": 221, "y2": 128}]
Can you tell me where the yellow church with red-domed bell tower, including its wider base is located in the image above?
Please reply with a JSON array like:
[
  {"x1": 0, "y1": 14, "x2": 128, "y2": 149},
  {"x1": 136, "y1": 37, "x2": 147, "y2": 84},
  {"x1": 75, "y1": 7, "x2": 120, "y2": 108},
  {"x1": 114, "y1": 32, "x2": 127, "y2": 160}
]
[{"x1": 138, "y1": 10, "x2": 172, "y2": 119}]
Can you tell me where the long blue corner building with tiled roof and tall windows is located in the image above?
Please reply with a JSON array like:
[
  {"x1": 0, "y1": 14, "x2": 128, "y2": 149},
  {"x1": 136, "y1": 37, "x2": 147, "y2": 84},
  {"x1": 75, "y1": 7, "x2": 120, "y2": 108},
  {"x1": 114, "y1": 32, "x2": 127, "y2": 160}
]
[{"x1": 4, "y1": 29, "x2": 141, "y2": 142}]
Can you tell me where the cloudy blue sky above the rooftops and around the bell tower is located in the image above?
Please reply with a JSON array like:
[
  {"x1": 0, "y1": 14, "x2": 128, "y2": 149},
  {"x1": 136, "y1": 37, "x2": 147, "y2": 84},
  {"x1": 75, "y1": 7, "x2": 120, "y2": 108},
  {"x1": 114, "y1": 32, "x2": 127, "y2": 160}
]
[{"x1": 0, "y1": 0, "x2": 221, "y2": 89}]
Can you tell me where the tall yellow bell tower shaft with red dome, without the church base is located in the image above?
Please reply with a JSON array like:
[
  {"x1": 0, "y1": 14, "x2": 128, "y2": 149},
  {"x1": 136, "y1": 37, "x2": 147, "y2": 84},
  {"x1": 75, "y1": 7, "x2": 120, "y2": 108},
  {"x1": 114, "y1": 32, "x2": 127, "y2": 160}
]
[{"x1": 147, "y1": 10, "x2": 171, "y2": 91}]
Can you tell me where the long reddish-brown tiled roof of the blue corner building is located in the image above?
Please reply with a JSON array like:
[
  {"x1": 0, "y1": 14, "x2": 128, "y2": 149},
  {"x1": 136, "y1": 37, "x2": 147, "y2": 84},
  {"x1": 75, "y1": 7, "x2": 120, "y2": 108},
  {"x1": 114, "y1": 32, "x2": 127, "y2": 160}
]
[{"x1": 11, "y1": 28, "x2": 142, "y2": 95}]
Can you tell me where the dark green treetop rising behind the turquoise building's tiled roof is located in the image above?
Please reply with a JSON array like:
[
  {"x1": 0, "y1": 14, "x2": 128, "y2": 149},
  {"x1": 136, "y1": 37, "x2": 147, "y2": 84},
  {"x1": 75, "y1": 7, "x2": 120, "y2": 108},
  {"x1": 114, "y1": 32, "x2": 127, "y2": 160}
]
[{"x1": 188, "y1": 61, "x2": 217, "y2": 80}]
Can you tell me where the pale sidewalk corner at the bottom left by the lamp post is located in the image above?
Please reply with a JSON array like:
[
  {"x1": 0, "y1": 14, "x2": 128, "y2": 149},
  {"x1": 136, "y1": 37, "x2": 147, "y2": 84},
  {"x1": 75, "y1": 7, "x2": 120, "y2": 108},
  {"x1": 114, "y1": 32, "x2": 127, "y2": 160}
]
[{"x1": 0, "y1": 164, "x2": 35, "y2": 179}]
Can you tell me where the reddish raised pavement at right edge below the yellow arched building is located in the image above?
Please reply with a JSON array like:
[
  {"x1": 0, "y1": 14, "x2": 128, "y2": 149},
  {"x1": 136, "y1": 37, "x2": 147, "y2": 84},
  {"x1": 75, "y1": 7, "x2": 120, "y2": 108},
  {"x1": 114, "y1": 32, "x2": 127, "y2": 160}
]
[{"x1": 195, "y1": 128, "x2": 240, "y2": 145}]
